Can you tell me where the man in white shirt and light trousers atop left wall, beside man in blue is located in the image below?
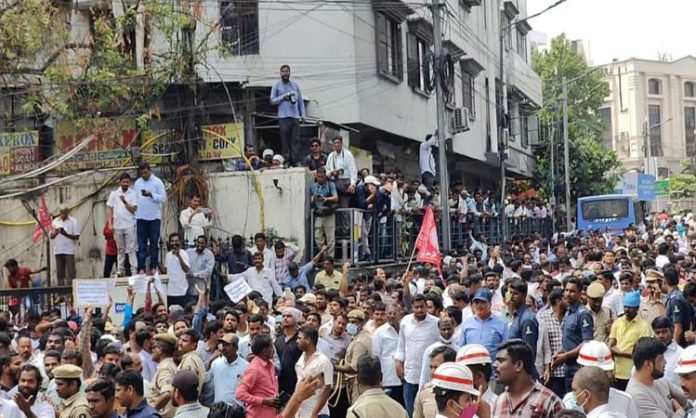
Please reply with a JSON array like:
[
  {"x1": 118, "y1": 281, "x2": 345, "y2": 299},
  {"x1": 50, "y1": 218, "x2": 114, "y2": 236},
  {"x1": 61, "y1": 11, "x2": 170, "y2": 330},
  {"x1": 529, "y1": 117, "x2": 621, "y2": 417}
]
[{"x1": 106, "y1": 173, "x2": 138, "y2": 276}]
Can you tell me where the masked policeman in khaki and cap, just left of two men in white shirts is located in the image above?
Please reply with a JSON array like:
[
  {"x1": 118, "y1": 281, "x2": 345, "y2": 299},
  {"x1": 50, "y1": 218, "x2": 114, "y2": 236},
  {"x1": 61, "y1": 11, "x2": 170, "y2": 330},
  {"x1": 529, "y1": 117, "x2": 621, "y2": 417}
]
[{"x1": 336, "y1": 309, "x2": 372, "y2": 403}]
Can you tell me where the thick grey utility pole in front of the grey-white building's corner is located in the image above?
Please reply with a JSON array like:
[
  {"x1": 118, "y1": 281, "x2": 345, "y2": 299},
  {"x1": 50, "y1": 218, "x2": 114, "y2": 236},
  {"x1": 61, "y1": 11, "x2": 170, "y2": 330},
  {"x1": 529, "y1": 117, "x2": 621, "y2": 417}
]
[{"x1": 432, "y1": 0, "x2": 452, "y2": 252}]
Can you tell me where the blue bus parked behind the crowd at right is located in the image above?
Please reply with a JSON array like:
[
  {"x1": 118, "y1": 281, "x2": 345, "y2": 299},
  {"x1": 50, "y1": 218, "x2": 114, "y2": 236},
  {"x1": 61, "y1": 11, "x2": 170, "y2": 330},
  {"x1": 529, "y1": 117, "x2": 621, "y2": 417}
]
[{"x1": 577, "y1": 194, "x2": 643, "y2": 233}]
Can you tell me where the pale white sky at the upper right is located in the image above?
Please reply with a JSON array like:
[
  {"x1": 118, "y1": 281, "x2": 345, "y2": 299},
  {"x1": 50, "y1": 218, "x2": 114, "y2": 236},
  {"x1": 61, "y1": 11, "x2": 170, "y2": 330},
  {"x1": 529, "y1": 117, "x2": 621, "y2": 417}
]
[{"x1": 527, "y1": 0, "x2": 696, "y2": 65}]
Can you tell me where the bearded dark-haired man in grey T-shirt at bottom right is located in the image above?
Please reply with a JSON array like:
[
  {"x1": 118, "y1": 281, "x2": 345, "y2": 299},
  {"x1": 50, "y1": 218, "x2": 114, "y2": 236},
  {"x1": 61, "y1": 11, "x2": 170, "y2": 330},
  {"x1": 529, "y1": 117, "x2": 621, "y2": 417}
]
[{"x1": 626, "y1": 337, "x2": 686, "y2": 418}]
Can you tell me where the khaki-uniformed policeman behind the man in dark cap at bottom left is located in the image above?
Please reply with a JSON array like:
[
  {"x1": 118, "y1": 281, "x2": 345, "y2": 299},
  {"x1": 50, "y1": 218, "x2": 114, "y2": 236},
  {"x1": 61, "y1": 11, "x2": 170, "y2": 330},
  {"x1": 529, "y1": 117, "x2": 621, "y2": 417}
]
[{"x1": 147, "y1": 333, "x2": 178, "y2": 418}]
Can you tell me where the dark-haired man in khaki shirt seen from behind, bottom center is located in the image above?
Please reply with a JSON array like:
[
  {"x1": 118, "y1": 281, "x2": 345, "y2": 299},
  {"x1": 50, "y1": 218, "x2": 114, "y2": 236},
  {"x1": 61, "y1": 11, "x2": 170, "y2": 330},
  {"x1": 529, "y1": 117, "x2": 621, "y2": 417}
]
[{"x1": 346, "y1": 356, "x2": 408, "y2": 418}]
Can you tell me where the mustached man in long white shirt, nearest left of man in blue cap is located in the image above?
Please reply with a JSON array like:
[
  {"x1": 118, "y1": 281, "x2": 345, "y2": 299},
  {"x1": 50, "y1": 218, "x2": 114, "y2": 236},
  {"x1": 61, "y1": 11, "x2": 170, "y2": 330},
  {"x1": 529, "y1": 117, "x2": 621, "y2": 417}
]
[{"x1": 394, "y1": 295, "x2": 440, "y2": 416}]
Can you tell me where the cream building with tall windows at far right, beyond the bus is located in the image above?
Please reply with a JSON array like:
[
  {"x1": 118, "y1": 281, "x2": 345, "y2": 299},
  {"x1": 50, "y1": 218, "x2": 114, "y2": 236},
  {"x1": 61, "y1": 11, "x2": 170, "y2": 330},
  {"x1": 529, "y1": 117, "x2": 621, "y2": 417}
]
[{"x1": 600, "y1": 56, "x2": 696, "y2": 178}]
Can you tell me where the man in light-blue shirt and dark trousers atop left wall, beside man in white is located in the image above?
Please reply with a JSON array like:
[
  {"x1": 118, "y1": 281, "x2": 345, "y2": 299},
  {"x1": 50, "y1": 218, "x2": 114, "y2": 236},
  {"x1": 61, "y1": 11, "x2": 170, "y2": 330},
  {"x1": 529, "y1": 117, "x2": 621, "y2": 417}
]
[{"x1": 135, "y1": 163, "x2": 167, "y2": 274}]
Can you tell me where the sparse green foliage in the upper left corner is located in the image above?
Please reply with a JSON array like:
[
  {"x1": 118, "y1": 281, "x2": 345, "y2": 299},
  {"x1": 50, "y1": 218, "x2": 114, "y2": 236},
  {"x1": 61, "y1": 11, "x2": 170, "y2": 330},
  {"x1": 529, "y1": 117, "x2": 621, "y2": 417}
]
[{"x1": 0, "y1": 0, "x2": 215, "y2": 126}]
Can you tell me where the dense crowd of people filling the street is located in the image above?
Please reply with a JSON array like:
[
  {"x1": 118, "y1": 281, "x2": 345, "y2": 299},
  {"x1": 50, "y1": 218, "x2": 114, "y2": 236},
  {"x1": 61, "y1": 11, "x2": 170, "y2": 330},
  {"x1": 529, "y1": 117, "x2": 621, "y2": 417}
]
[{"x1": 0, "y1": 204, "x2": 696, "y2": 418}]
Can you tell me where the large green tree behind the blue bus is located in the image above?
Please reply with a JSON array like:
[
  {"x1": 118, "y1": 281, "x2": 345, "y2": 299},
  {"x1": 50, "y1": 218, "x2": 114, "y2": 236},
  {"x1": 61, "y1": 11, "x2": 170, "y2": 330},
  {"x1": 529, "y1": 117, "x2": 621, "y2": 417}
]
[{"x1": 532, "y1": 35, "x2": 623, "y2": 203}]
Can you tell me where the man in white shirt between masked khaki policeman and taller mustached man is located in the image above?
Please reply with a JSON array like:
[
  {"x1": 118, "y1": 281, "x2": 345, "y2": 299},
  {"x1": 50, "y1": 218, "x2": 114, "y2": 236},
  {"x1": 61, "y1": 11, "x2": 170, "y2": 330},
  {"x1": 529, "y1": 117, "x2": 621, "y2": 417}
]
[{"x1": 372, "y1": 304, "x2": 404, "y2": 404}]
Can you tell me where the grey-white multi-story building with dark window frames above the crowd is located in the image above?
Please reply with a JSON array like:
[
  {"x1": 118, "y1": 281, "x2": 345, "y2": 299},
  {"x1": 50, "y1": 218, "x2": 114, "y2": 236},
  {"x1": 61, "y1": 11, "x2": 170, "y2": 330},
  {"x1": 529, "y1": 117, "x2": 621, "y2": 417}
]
[{"x1": 1, "y1": 0, "x2": 542, "y2": 187}]
